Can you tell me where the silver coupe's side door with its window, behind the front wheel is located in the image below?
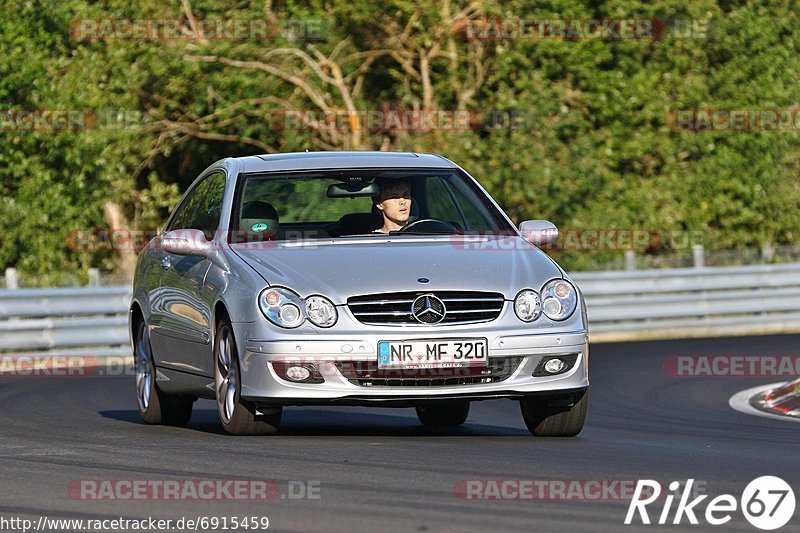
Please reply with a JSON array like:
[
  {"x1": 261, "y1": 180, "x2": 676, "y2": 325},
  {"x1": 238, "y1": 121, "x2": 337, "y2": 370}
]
[{"x1": 152, "y1": 171, "x2": 225, "y2": 375}]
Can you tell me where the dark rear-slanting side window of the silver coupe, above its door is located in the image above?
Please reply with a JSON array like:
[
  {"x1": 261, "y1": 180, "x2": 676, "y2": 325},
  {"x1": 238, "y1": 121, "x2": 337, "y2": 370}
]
[{"x1": 167, "y1": 172, "x2": 225, "y2": 240}]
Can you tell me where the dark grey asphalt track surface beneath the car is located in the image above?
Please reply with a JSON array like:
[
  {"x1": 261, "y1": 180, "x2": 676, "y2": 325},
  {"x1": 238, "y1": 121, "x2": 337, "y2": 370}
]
[{"x1": 0, "y1": 335, "x2": 800, "y2": 532}]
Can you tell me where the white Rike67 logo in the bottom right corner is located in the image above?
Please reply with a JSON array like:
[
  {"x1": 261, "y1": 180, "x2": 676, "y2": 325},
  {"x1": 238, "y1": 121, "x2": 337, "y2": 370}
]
[{"x1": 625, "y1": 476, "x2": 795, "y2": 530}]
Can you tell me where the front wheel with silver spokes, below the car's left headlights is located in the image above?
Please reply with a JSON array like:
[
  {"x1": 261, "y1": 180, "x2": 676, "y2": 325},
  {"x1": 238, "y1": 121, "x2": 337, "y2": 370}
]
[{"x1": 214, "y1": 317, "x2": 281, "y2": 435}]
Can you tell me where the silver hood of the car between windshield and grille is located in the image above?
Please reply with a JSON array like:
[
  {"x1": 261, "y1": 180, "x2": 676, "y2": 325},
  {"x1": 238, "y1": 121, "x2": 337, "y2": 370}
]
[{"x1": 231, "y1": 236, "x2": 562, "y2": 305}]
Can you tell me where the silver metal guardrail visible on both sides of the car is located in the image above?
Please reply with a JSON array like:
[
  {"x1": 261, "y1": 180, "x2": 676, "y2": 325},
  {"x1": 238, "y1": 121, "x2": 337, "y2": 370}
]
[{"x1": 0, "y1": 263, "x2": 800, "y2": 355}]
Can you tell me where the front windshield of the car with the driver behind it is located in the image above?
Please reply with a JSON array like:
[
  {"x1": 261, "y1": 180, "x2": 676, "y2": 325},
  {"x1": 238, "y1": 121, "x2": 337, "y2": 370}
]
[{"x1": 233, "y1": 169, "x2": 514, "y2": 242}]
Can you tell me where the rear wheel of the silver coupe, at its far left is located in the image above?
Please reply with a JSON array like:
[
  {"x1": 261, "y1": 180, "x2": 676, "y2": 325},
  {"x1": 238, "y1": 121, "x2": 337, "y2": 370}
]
[{"x1": 133, "y1": 320, "x2": 194, "y2": 426}]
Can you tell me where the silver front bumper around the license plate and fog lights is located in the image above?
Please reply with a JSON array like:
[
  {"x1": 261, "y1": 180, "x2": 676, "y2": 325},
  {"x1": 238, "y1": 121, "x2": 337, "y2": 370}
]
[{"x1": 234, "y1": 324, "x2": 589, "y2": 406}]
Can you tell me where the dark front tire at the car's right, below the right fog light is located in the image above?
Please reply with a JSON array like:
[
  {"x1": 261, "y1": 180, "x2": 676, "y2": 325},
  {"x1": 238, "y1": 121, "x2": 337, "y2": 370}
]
[{"x1": 519, "y1": 389, "x2": 589, "y2": 437}]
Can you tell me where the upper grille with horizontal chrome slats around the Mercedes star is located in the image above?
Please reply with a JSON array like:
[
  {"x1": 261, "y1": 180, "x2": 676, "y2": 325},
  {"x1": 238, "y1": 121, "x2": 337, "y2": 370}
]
[{"x1": 347, "y1": 291, "x2": 503, "y2": 325}]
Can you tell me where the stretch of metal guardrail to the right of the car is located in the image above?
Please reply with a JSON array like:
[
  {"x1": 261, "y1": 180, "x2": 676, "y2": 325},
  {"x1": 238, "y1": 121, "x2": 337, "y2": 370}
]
[{"x1": 573, "y1": 263, "x2": 800, "y2": 341}]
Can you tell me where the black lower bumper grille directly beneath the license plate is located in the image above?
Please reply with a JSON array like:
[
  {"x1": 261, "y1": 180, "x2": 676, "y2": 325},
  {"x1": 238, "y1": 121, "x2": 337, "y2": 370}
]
[{"x1": 336, "y1": 356, "x2": 524, "y2": 387}]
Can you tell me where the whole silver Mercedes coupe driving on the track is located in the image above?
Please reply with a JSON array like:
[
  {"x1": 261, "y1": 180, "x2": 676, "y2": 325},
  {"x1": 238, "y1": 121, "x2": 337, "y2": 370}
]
[{"x1": 130, "y1": 152, "x2": 589, "y2": 436}]
